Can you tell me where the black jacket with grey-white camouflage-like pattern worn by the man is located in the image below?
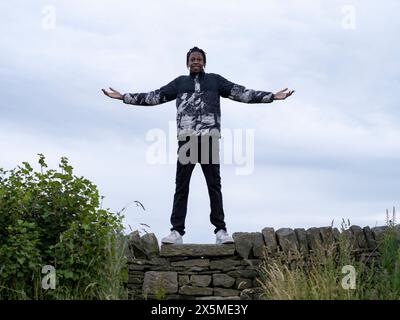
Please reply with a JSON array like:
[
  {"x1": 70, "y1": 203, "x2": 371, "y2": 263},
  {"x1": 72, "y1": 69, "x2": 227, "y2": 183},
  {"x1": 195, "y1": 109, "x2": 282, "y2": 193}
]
[{"x1": 123, "y1": 72, "x2": 274, "y2": 138}]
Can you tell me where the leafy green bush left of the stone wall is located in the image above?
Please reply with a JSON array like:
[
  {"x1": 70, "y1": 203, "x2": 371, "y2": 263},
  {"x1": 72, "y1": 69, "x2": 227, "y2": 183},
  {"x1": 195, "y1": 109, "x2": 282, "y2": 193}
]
[{"x1": 0, "y1": 154, "x2": 127, "y2": 299}]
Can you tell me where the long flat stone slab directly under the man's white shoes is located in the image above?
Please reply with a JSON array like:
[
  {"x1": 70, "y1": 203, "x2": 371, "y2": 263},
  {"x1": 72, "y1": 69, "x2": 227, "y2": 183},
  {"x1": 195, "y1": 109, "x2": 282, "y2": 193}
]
[{"x1": 160, "y1": 244, "x2": 235, "y2": 257}]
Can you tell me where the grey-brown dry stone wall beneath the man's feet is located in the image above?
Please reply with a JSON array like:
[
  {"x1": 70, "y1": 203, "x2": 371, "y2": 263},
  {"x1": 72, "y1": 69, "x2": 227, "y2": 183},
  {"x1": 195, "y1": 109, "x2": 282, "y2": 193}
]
[{"x1": 127, "y1": 226, "x2": 396, "y2": 300}]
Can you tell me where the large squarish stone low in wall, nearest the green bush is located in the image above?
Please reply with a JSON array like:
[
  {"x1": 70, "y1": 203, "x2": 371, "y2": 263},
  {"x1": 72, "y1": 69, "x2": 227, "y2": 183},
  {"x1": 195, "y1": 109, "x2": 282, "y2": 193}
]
[{"x1": 142, "y1": 271, "x2": 178, "y2": 294}]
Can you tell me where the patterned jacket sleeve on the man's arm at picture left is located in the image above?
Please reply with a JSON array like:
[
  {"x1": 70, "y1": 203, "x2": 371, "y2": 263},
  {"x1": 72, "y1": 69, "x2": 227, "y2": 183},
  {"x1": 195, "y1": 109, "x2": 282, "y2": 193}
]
[{"x1": 123, "y1": 79, "x2": 177, "y2": 106}]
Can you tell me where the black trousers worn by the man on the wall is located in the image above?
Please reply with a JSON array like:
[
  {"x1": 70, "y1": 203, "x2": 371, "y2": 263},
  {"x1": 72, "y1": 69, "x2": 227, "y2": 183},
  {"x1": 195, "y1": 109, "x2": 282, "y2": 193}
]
[{"x1": 171, "y1": 136, "x2": 226, "y2": 235}]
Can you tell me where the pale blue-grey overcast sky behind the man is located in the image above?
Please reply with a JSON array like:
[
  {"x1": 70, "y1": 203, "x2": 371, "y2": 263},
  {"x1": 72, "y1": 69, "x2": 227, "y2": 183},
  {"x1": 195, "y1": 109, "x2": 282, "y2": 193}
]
[{"x1": 0, "y1": 0, "x2": 400, "y2": 243}]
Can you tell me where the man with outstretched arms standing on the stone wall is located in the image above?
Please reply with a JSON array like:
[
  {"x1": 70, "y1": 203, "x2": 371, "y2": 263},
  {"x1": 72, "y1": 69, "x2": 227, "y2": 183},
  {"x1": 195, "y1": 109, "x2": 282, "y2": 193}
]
[{"x1": 102, "y1": 47, "x2": 294, "y2": 244}]
